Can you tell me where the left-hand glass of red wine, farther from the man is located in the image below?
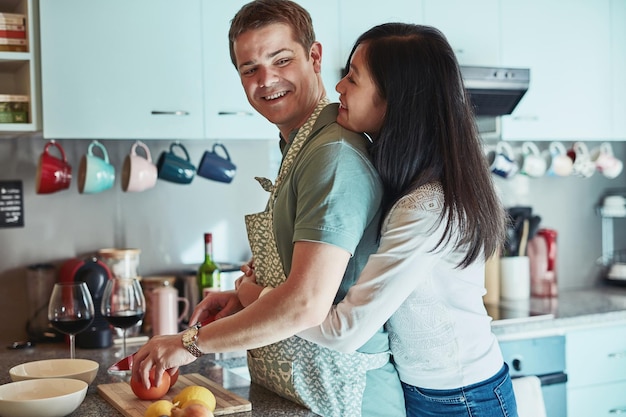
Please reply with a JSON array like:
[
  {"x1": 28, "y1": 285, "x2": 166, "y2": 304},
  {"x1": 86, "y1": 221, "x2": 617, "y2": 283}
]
[{"x1": 48, "y1": 282, "x2": 95, "y2": 359}]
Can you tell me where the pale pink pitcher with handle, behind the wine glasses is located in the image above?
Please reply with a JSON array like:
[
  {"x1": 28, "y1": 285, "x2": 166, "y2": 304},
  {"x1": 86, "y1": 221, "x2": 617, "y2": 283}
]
[{"x1": 150, "y1": 281, "x2": 189, "y2": 336}]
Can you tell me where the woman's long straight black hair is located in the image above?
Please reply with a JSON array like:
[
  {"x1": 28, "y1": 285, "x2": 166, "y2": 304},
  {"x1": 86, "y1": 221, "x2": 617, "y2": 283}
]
[{"x1": 348, "y1": 23, "x2": 505, "y2": 267}]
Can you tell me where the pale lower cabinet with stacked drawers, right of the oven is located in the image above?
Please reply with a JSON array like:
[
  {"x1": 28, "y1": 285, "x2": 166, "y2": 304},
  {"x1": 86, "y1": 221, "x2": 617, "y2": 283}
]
[{"x1": 566, "y1": 325, "x2": 626, "y2": 417}]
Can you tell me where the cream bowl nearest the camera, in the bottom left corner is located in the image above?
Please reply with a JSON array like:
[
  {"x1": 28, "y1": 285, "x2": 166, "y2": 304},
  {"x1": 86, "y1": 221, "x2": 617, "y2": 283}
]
[{"x1": 0, "y1": 378, "x2": 88, "y2": 417}]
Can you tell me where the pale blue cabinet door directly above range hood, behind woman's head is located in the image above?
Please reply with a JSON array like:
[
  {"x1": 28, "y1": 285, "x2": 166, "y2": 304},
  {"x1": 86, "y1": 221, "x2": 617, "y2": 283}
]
[{"x1": 423, "y1": 0, "x2": 500, "y2": 66}]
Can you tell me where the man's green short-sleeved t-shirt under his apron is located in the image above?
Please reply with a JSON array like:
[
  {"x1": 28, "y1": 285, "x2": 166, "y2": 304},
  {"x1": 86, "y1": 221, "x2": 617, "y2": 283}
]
[{"x1": 273, "y1": 104, "x2": 405, "y2": 417}]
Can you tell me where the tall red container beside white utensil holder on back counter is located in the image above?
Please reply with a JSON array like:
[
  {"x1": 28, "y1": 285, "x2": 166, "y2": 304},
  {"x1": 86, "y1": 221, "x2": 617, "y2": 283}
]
[{"x1": 528, "y1": 229, "x2": 558, "y2": 297}]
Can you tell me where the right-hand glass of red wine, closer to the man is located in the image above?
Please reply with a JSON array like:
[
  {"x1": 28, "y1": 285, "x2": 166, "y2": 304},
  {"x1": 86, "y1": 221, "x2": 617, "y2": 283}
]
[{"x1": 100, "y1": 278, "x2": 146, "y2": 358}]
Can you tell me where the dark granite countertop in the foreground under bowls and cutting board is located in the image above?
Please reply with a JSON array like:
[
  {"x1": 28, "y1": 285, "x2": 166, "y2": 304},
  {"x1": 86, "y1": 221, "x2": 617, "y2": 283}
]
[{"x1": 0, "y1": 343, "x2": 317, "y2": 417}]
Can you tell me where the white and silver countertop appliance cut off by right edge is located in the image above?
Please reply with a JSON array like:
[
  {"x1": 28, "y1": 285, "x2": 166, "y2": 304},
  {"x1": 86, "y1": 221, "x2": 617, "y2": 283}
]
[{"x1": 596, "y1": 189, "x2": 626, "y2": 286}]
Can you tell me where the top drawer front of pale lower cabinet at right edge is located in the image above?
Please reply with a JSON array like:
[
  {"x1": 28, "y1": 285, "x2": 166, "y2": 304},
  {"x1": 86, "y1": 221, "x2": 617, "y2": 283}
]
[{"x1": 566, "y1": 325, "x2": 626, "y2": 389}]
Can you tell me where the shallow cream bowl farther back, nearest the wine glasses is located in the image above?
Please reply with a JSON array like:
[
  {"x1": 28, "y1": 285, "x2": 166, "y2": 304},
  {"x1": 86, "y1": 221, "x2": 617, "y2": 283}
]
[{"x1": 9, "y1": 359, "x2": 100, "y2": 384}]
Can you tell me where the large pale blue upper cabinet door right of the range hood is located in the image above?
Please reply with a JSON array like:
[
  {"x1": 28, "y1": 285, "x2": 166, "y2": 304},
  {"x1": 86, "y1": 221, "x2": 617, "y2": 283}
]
[{"x1": 501, "y1": 0, "x2": 611, "y2": 141}]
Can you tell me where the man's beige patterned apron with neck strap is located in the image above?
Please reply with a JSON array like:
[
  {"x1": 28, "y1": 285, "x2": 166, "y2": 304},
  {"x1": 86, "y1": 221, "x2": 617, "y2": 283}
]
[{"x1": 241, "y1": 99, "x2": 389, "y2": 417}]
